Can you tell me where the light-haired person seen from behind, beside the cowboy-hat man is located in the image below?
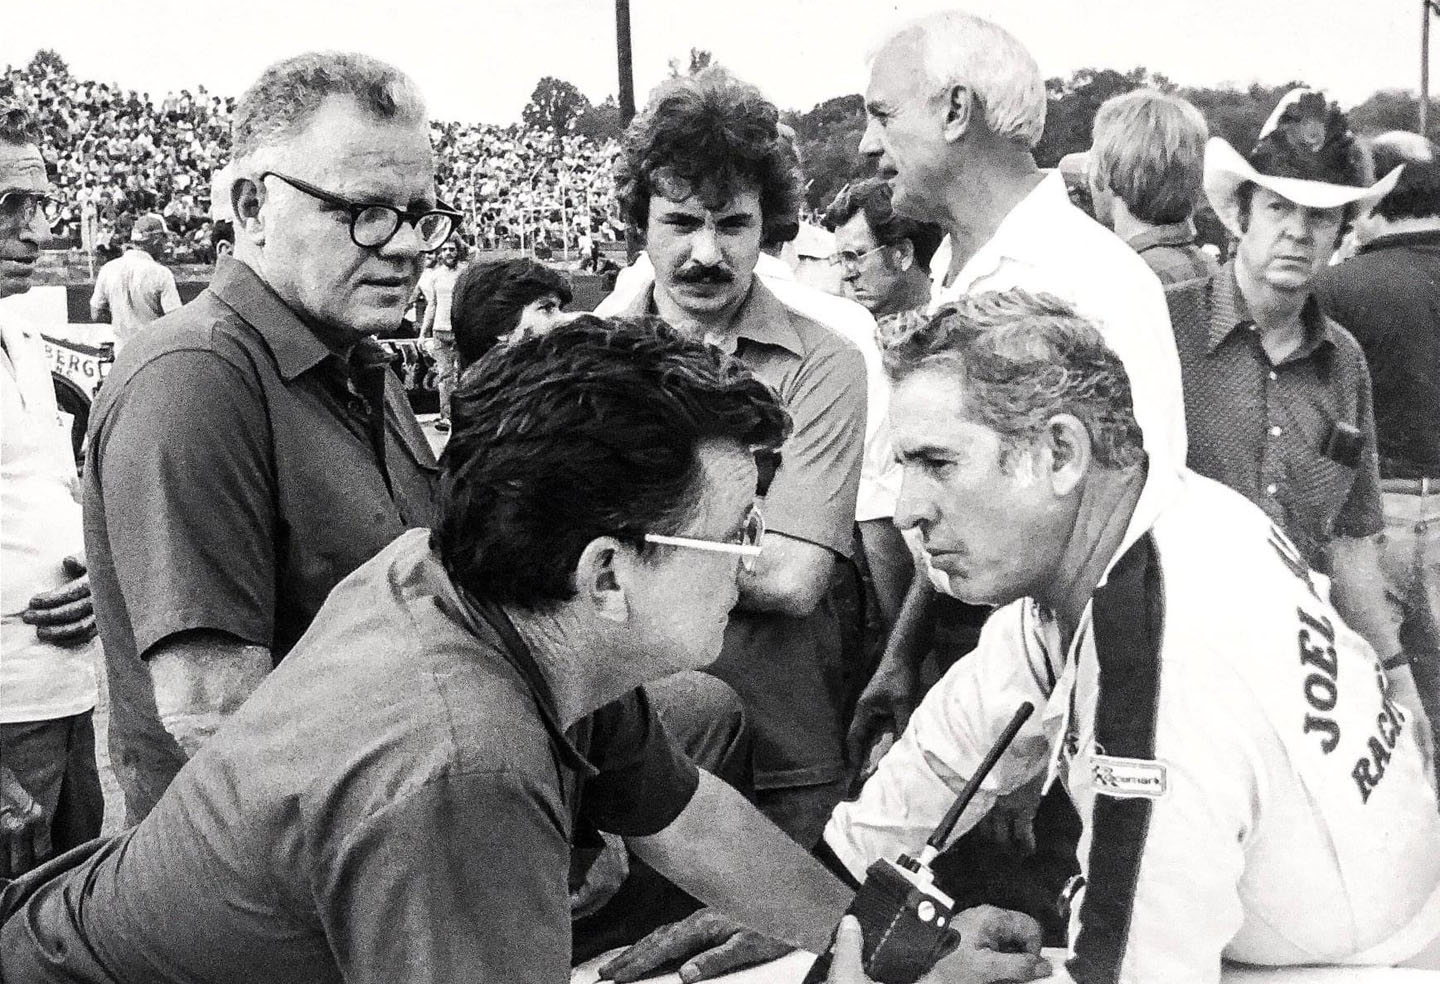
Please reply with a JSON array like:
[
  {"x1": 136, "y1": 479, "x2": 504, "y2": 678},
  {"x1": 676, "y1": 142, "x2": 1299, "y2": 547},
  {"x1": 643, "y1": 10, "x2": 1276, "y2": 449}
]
[{"x1": 1086, "y1": 89, "x2": 1218, "y2": 287}]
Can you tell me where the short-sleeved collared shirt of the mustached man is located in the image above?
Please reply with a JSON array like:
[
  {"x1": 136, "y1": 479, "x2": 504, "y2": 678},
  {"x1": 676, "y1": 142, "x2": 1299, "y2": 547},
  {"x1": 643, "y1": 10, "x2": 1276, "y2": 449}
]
[{"x1": 610, "y1": 278, "x2": 865, "y2": 790}]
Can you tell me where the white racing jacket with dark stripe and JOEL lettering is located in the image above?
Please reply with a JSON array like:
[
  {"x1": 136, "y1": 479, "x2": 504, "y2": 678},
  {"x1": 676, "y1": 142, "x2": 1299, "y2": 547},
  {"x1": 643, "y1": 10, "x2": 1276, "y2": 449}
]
[{"x1": 825, "y1": 473, "x2": 1440, "y2": 984}]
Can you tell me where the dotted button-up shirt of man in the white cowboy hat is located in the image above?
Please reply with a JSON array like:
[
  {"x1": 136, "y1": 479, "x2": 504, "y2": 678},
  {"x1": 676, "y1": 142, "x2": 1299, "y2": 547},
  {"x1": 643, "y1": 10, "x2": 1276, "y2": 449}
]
[{"x1": 1166, "y1": 264, "x2": 1384, "y2": 573}]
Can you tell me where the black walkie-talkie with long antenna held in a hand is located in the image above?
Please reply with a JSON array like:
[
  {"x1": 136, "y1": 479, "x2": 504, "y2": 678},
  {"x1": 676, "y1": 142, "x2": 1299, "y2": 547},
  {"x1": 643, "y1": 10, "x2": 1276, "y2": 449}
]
[{"x1": 804, "y1": 700, "x2": 1035, "y2": 984}]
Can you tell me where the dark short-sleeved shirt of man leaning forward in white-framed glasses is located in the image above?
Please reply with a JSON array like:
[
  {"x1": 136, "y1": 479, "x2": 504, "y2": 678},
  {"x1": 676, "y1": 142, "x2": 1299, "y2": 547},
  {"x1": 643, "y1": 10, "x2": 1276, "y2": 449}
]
[{"x1": 0, "y1": 530, "x2": 698, "y2": 984}]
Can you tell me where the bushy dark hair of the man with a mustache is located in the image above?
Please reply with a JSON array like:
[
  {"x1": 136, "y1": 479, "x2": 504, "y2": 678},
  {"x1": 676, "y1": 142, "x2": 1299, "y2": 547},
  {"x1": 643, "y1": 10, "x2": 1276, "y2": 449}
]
[{"x1": 615, "y1": 68, "x2": 802, "y2": 243}]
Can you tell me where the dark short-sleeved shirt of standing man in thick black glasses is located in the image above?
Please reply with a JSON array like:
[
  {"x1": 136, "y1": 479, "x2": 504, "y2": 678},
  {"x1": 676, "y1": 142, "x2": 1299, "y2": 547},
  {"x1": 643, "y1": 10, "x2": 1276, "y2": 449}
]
[{"x1": 85, "y1": 261, "x2": 436, "y2": 821}]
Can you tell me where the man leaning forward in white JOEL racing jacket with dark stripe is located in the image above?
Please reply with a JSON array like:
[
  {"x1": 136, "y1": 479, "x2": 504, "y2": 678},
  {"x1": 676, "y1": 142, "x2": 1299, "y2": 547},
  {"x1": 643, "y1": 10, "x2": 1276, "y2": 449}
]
[{"x1": 602, "y1": 288, "x2": 1440, "y2": 984}]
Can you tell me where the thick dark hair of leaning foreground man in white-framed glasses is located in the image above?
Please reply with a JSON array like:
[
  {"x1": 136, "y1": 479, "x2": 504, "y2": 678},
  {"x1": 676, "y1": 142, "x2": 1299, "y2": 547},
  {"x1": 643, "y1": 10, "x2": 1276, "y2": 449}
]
[{"x1": 431, "y1": 316, "x2": 791, "y2": 609}]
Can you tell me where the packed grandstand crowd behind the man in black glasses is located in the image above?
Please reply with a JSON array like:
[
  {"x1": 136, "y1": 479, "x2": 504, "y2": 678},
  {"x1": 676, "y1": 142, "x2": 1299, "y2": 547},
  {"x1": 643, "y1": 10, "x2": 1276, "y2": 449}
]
[{"x1": 0, "y1": 57, "x2": 624, "y2": 262}]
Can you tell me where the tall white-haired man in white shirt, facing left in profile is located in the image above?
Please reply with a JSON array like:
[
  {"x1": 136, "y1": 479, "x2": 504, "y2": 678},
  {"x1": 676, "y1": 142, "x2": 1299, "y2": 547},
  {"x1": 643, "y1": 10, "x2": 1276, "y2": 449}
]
[{"x1": 851, "y1": 10, "x2": 1185, "y2": 806}]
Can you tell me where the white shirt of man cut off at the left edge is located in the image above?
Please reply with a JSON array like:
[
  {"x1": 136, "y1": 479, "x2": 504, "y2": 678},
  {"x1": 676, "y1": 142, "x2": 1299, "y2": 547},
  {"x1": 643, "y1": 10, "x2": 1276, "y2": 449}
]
[{"x1": 0, "y1": 321, "x2": 96, "y2": 725}]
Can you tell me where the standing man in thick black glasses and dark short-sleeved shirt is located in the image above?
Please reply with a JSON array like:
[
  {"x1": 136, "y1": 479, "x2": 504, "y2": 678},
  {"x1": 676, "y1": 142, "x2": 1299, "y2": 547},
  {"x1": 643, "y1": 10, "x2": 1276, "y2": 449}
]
[{"x1": 85, "y1": 53, "x2": 458, "y2": 823}]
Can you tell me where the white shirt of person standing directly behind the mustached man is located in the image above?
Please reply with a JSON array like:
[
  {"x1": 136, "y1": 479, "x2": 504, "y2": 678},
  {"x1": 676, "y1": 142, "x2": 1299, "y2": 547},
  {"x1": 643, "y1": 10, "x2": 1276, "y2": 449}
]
[{"x1": 595, "y1": 252, "x2": 903, "y2": 523}]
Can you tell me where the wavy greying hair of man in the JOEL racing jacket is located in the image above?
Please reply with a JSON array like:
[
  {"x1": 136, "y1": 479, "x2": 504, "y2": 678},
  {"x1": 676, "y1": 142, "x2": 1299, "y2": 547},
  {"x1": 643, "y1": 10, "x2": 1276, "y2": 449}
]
[{"x1": 883, "y1": 287, "x2": 1143, "y2": 468}]
